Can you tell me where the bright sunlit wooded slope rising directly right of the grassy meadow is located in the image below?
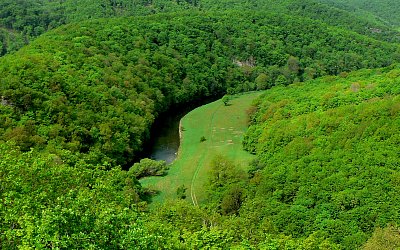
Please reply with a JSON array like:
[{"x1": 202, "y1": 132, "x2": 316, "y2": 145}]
[{"x1": 238, "y1": 66, "x2": 400, "y2": 249}]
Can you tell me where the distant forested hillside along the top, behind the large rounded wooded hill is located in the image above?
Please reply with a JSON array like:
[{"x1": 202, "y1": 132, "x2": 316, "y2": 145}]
[{"x1": 0, "y1": 0, "x2": 400, "y2": 56}]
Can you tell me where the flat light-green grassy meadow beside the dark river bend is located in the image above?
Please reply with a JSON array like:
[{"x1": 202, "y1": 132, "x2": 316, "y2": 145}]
[{"x1": 141, "y1": 92, "x2": 261, "y2": 205}]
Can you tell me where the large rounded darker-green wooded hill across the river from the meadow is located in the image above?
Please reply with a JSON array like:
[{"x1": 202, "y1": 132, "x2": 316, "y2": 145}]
[{"x1": 0, "y1": 12, "x2": 399, "y2": 166}]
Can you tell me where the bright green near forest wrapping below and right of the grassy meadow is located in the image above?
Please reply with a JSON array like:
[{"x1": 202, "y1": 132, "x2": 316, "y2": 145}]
[{"x1": 0, "y1": 66, "x2": 400, "y2": 249}]
